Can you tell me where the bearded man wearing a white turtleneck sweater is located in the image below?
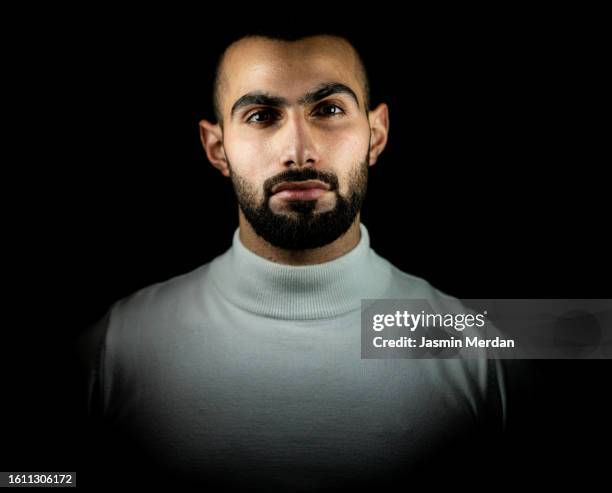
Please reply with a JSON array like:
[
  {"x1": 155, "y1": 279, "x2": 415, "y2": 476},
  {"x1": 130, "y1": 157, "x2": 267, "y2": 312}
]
[{"x1": 76, "y1": 35, "x2": 505, "y2": 491}]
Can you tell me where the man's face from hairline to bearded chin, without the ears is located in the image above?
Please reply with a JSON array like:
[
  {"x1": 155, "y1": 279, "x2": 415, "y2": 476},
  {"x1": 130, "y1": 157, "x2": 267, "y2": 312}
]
[{"x1": 219, "y1": 37, "x2": 370, "y2": 250}]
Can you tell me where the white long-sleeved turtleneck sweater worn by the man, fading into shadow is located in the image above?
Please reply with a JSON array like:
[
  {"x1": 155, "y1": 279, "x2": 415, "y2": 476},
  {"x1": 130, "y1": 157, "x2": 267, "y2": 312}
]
[{"x1": 81, "y1": 224, "x2": 505, "y2": 491}]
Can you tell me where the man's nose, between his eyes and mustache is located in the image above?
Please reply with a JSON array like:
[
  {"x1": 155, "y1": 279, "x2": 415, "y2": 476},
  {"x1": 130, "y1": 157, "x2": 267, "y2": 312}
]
[{"x1": 280, "y1": 111, "x2": 319, "y2": 167}]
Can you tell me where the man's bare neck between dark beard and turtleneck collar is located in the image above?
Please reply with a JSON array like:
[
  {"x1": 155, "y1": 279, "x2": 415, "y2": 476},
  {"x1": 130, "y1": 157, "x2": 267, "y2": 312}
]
[{"x1": 238, "y1": 210, "x2": 361, "y2": 265}]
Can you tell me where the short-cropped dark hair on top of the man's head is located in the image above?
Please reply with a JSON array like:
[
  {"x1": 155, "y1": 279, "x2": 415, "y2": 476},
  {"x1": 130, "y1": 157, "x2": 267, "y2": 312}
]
[{"x1": 212, "y1": 29, "x2": 370, "y2": 126}]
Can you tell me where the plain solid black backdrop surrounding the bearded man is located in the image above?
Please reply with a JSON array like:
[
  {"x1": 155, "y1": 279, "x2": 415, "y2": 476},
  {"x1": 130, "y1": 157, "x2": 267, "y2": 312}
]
[{"x1": 0, "y1": 5, "x2": 611, "y2": 487}]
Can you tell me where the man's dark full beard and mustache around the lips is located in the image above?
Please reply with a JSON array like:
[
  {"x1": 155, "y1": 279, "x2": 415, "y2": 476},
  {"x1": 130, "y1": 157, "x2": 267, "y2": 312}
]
[{"x1": 228, "y1": 158, "x2": 369, "y2": 250}]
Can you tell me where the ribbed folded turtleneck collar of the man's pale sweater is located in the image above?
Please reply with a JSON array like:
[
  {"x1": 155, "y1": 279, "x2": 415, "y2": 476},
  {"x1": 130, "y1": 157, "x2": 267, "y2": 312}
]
[{"x1": 210, "y1": 223, "x2": 392, "y2": 320}]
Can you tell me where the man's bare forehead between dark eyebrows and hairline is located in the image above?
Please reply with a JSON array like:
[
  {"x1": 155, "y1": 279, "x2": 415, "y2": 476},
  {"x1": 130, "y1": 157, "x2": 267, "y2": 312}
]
[{"x1": 222, "y1": 37, "x2": 360, "y2": 104}]
